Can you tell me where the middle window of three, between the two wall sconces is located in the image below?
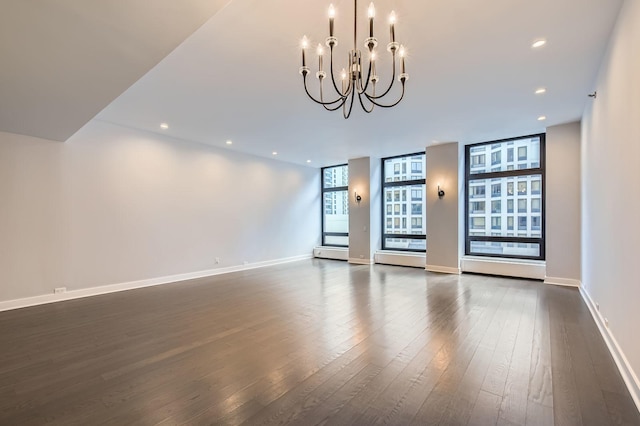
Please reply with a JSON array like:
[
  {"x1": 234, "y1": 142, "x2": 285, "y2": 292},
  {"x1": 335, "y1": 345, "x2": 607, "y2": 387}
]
[{"x1": 382, "y1": 152, "x2": 427, "y2": 251}]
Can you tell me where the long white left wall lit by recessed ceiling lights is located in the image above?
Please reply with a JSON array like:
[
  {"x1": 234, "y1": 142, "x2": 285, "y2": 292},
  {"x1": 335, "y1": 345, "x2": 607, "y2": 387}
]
[{"x1": 0, "y1": 121, "x2": 320, "y2": 301}]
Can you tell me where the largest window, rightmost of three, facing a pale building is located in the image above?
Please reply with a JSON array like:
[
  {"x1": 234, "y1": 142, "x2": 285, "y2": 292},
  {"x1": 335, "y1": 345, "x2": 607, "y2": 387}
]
[{"x1": 465, "y1": 134, "x2": 545, "y2": 259}]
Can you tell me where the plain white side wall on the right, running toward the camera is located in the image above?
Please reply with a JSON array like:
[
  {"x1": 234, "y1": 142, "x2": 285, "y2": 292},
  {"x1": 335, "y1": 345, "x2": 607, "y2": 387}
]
[{"x1": 581, "y1": 0, "x2": 640, "y2": 403}]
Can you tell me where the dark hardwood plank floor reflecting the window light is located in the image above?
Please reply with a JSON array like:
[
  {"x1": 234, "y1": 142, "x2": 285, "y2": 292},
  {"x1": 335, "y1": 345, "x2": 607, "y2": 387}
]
[{"x1": 0, "y1": 260, "x2": 640, "y2": 426}]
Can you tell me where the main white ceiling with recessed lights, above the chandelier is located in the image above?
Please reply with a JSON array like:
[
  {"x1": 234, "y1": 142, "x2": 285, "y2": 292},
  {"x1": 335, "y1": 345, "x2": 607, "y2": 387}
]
[{"x1": 0, "y1": 0, "x2": 623, "y2": 167}]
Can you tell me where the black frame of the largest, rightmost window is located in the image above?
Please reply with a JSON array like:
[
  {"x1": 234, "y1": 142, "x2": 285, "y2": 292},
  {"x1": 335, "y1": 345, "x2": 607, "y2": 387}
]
[{"x1": 464, "y1": 133, "x2": 546, "y2": 260}]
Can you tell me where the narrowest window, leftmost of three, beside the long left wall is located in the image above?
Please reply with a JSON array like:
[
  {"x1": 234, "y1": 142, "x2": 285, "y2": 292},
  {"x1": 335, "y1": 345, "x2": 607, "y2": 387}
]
[{"x1": 321, "y1": 164, "x2": 349, "y2": 247}]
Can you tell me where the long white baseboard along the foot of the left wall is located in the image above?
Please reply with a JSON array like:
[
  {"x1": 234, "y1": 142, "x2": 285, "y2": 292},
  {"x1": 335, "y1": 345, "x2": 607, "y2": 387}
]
[{"x1": 0, "y1": 255, "x2": 311, "y2": 312}]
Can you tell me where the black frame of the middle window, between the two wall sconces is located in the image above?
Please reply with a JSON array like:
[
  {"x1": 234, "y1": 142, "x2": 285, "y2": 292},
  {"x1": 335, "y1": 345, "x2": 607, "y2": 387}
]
[{"x1": 380, "y1": 151, "x2": 427, "y2": 253}]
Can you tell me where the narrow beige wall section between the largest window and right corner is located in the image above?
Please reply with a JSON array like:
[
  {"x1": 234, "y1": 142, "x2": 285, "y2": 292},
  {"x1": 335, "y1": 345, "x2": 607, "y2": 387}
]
[{"x1": 545, "y1": 122, "x2": 581, "y2": 286}]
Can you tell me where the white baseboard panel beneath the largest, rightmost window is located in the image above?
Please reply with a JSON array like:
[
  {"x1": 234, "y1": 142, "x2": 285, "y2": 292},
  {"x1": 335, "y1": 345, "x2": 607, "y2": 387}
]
[{"x1": 460, "y1": 256, "x2": 547, "y2": 280}]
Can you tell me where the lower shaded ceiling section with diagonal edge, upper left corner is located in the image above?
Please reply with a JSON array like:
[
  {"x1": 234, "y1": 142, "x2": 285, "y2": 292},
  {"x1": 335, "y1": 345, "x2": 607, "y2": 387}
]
[{"x1": 0, "y1": 0, "x2": 229, "y2": 141}]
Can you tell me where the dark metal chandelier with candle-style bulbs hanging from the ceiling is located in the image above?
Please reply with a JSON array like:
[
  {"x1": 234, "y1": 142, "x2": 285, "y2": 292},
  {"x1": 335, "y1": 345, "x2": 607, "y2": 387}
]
[{"x1": 300, "y1": 0, "x2": 409, "y2": 118}]
